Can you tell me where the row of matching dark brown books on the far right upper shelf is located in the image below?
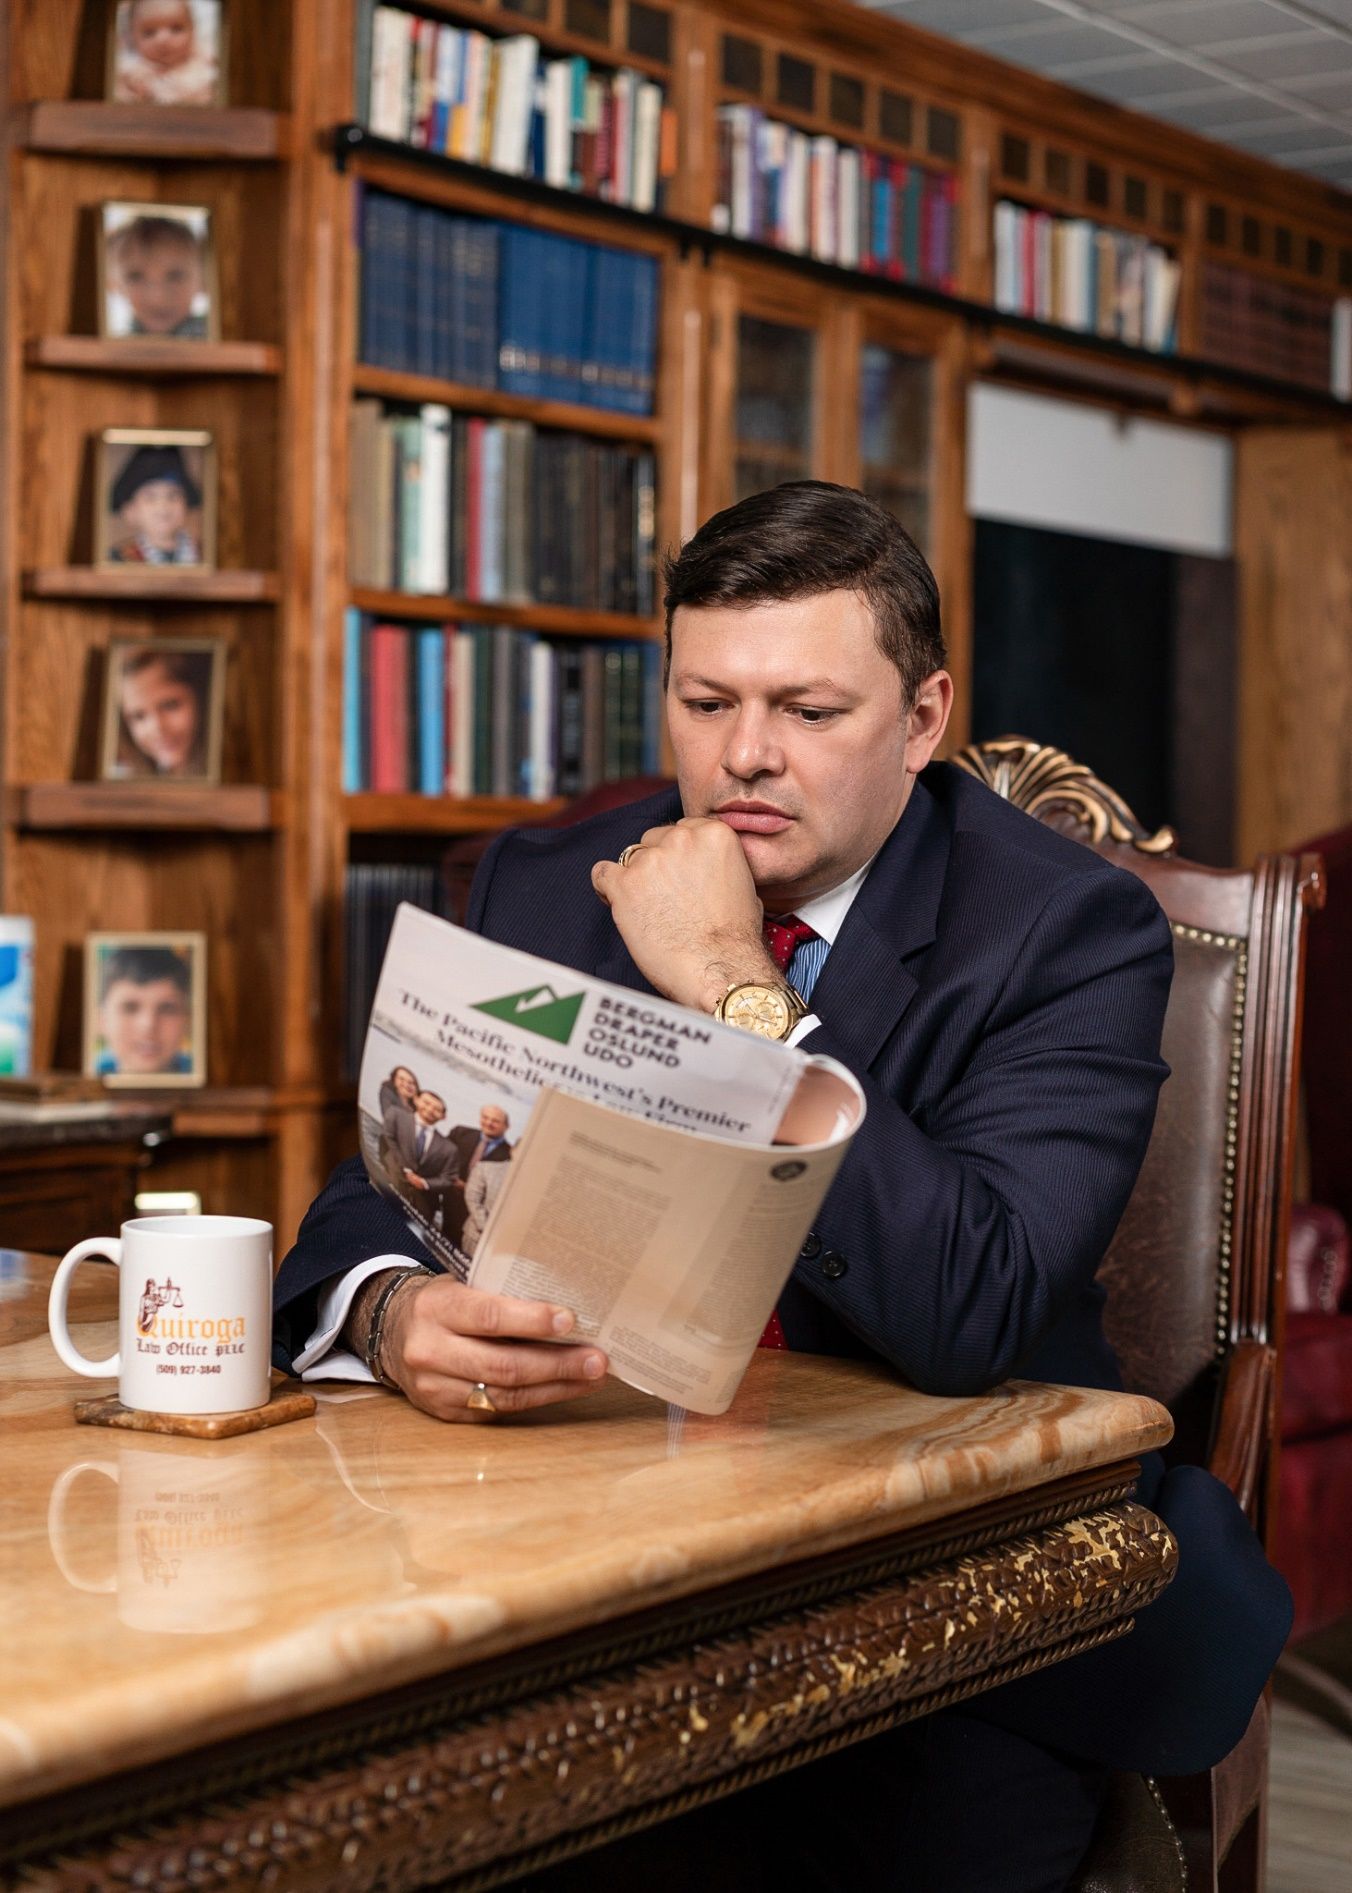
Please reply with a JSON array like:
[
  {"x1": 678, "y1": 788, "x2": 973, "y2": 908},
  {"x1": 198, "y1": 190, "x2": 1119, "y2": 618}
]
[{"x1": 1199, "y1": 261, "x2": 1352, "y2": 401}]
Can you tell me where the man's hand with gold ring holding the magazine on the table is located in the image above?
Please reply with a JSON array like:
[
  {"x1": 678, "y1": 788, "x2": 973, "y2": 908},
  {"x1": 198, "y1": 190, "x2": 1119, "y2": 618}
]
[{"x1": 361, "y1": 1274, "x2": 606, "y2": 1420}]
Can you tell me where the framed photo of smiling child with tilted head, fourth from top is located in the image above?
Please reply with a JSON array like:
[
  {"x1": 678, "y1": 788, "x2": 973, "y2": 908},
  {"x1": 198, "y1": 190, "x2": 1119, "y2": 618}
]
[{"x1": 98, "y1": 638, "x2": 225, "y2": 784}]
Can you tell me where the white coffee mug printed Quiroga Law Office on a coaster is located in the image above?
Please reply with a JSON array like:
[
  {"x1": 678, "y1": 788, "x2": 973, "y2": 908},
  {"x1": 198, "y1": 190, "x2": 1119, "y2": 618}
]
[{"x1": 47, "y1": 1215, "x2": 273, "y2": 1414}]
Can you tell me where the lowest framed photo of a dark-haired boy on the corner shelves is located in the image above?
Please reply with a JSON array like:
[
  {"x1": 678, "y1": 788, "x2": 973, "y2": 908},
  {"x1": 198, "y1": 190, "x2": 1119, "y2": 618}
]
[{"x1": 83, "y1": 933, "x2": 206, "y2": 1087}]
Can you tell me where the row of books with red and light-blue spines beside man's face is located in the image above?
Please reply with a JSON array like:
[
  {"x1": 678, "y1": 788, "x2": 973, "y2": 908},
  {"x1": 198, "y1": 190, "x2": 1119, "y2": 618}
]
[{"x1": 343, "y1": 610, "x2": 663, "y2": 803}]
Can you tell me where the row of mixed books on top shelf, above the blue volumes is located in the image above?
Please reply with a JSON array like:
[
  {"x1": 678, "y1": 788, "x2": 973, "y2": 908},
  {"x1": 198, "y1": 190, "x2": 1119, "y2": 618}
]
[{"x1": 365, "y1": 6, "x2": 676, "y2": 210}]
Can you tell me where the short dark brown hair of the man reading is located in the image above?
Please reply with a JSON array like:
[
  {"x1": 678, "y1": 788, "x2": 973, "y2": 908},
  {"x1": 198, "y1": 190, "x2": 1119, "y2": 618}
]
[{"x1": 663, "y1": 479, "x2": 945, "y2": 704}]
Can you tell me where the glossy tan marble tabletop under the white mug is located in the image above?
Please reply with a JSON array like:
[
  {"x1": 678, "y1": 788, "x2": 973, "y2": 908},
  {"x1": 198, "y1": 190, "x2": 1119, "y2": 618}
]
[{"x1": 0, "y1": 1251, "x2": 1170, "y2": 1804}]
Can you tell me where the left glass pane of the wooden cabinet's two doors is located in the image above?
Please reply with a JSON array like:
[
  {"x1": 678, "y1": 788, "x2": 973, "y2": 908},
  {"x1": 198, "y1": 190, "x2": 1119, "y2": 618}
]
[{"x1": 733, "y1": 314, "x2": 816, "y2": 500}]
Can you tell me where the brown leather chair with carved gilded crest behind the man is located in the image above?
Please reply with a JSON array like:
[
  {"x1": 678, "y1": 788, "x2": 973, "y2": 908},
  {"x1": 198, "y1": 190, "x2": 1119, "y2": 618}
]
[{"x1": 954, "y1": 738, "x2": 1322, "y2": 1893}]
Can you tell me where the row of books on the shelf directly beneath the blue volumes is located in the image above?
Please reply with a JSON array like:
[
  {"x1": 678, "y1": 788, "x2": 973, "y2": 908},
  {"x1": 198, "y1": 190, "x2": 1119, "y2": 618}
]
[{"x1": 348, "y1": 398, "x2": 657, "y2": 615}]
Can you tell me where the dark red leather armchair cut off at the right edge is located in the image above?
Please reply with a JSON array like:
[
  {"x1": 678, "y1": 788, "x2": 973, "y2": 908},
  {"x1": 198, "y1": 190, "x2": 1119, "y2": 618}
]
[{"x1": 1276, "y1": 813, "x2": 1352, "y2": 1641}]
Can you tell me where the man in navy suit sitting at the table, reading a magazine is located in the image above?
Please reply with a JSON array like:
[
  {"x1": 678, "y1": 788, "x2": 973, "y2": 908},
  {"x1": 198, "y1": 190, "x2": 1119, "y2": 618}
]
[{"x1": 278, "y1": 481, "x2": 1286, "y2": 1893}]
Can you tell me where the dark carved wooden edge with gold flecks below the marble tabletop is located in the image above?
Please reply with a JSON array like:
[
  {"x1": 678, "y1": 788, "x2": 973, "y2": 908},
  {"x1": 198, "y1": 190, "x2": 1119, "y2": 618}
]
[{"x1": 0, "y1": 1463, "x2": 1178, "y2": 1893}]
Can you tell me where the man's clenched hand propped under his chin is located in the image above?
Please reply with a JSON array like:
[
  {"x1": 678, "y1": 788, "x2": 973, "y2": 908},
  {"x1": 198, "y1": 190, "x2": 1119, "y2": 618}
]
[{"x1": 591, "y1": 816, "x2": 780, "y2": 1013}]
